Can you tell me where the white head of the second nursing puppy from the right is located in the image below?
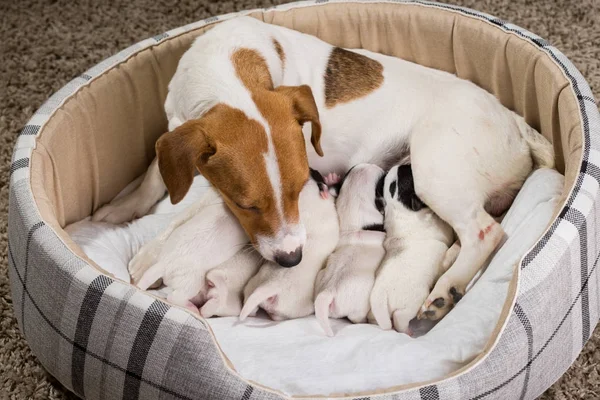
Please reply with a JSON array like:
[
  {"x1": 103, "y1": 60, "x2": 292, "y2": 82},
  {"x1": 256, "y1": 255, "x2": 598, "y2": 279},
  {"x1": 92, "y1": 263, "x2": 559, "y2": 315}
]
[{"x1": 336, "y1": 164, "x2": 384, "y2": 231}]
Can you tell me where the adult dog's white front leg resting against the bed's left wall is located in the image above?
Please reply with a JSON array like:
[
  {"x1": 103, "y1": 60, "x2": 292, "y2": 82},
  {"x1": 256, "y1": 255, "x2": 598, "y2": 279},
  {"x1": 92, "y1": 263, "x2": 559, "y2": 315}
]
[{"x1": 92, "y1": 157, "x2": 167, "y2": 224}]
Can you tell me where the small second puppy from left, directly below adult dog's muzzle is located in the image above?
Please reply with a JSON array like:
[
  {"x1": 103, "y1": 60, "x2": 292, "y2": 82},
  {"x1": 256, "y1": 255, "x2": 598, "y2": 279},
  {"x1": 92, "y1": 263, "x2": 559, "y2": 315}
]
[{"x1": 200, "y1": 248, "x2": 264, "y2": 318}]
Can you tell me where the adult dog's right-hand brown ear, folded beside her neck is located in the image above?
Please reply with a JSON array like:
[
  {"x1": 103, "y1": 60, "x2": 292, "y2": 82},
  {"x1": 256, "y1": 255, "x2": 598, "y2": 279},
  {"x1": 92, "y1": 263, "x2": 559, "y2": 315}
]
[{"x1": 275, "y1": 85, "x2": 323, "y2": 157}]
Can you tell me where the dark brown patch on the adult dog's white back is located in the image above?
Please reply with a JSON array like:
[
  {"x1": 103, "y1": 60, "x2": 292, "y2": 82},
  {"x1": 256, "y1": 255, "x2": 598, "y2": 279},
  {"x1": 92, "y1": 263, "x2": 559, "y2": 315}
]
[{"x1": 325, "y1": 47, "x2": 383, "y2": 108}]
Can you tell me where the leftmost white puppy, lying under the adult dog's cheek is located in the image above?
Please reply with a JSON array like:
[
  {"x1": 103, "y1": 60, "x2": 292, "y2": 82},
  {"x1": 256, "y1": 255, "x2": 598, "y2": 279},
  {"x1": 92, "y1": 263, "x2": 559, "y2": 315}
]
[{"x1": 129, "y1": 189, "x2": 249, "y2": 313}]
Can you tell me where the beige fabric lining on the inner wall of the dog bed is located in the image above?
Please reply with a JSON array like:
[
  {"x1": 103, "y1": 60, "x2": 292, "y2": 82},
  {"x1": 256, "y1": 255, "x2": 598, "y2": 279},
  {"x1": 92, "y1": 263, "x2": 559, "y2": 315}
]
[{"x1": 31, "y1": 4, "x2": 582, "y2": 231}]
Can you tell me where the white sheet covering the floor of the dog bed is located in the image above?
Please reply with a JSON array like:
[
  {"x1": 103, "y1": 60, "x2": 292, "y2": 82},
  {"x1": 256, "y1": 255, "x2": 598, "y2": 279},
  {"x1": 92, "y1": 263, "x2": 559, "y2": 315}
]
[{"x1": 65, "y1": 169, "x2": 564, "y2": 395}]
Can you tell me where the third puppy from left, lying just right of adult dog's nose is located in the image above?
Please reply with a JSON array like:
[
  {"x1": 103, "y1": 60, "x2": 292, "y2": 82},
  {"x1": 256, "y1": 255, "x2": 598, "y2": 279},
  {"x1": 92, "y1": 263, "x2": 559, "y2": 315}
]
[{"x1": 240, "y1": 180, "x2": 339, "y2": 321}]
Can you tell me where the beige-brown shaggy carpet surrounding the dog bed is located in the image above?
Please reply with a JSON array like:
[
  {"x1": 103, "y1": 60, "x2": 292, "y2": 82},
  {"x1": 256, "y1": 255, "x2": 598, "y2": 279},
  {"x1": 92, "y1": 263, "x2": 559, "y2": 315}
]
[{"x1": 0, "y1": 0, "x2": 600, "y2": 400}]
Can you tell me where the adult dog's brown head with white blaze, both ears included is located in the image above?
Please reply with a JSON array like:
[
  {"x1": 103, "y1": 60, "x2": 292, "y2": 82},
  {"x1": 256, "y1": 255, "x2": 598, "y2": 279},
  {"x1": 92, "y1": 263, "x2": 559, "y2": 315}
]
[{"x1": 156, "y1": 86, "x2": 322, "y2": 267}]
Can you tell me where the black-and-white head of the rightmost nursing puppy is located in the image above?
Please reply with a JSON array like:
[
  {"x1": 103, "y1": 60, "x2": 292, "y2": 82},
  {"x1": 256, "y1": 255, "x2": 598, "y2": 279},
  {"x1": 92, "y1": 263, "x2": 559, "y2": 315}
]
[{"x1": 382, "y1": 165, "x2": 427, "y2": 211}]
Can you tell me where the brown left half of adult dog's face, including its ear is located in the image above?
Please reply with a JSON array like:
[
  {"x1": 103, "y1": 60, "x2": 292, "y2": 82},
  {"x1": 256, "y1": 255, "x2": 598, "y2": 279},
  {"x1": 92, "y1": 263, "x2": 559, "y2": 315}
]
[{"x1": 156, "y1": 104, "x2": 281, "y2": 240}]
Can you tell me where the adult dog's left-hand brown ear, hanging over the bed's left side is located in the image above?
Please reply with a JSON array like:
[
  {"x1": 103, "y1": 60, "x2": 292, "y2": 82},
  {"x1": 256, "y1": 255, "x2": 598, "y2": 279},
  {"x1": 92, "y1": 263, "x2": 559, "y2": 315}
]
[{"x1": 156, "y1": 120, "x2": 216, "y2": 204}]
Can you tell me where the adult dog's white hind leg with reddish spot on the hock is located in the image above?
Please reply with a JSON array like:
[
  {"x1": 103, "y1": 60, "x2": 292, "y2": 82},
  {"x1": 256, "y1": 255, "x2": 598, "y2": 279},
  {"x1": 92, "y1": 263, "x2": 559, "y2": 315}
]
[{"x1": 411, "y1": 132, "x2": 509, "y2": 320}]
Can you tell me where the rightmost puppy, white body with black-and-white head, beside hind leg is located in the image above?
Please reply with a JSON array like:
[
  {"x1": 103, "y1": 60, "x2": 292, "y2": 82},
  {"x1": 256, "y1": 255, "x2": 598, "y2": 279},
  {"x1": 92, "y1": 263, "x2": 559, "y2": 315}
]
[{"x1": 371, "y1": 165, "x2": 459, "y2": 335}]
